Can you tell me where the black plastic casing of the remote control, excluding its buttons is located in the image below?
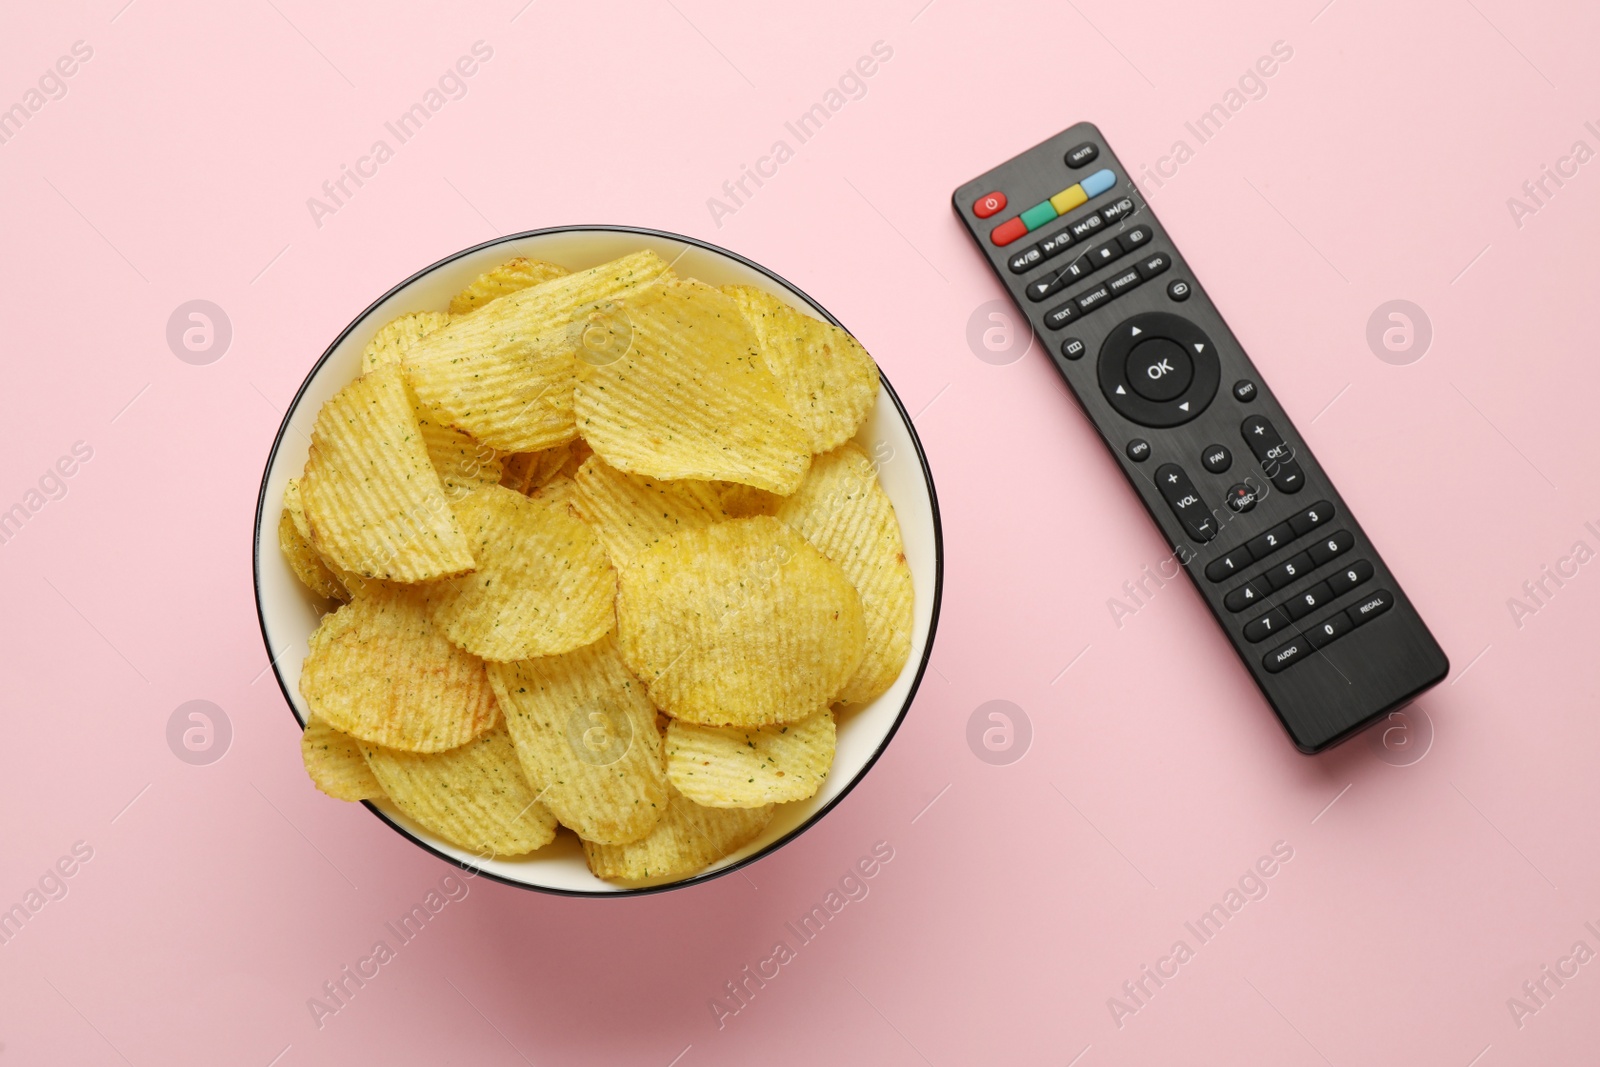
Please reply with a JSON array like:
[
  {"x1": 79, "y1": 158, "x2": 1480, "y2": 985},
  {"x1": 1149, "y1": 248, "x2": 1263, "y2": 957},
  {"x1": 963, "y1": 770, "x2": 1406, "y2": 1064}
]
[{"x1": 952, "y1": 123, "x2": 1450, "y2": 753}]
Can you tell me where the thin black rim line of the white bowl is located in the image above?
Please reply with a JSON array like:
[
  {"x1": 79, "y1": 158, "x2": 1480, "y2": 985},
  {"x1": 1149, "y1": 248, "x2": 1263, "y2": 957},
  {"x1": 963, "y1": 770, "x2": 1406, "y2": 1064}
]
[{"x1": 250, "y1": 224, "x2": 944, "y2": 899}]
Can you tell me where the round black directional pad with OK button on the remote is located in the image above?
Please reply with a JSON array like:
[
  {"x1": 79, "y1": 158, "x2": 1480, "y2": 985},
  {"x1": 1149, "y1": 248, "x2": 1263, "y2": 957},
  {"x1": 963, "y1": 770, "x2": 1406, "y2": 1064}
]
[{"x1": 1099, "y1": 312, "x2": 1222, "y2": 427}]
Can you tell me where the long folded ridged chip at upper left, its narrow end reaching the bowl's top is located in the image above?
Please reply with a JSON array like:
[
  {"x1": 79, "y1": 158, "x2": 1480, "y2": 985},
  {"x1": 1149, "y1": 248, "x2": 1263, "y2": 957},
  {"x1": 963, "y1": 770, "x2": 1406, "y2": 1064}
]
[{"x1": 405, "y1": 251, "x2": 667, "y2": 453}]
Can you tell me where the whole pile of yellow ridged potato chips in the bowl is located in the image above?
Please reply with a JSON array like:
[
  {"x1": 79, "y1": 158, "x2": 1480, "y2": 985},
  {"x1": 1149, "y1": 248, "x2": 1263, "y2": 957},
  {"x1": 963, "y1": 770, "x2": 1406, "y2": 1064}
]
[{"x1": 278, "y1": 251, "x2": 912, "y2": 883}]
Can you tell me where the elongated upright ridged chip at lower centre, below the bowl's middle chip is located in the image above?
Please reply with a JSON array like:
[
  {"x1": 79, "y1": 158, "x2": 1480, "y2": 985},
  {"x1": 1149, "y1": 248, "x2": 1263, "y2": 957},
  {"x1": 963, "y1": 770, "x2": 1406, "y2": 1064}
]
[{"x1": 490, "y1": 637, "x2": 667, "y2": 845}]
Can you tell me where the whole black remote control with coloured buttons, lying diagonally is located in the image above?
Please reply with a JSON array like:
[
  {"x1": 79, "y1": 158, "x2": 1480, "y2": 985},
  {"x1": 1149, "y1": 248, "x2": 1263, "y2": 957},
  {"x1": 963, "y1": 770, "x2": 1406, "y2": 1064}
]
[{"x1": 952, "y1": 123, "x2": 1450, "y2": 752}]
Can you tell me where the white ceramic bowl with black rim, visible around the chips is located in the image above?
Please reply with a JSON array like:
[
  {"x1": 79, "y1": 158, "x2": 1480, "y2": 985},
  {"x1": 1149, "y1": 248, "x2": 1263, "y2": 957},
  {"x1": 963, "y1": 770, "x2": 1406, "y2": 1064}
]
[{"x1": 254, "y1": 226, "x2": 944, "y2": 896}]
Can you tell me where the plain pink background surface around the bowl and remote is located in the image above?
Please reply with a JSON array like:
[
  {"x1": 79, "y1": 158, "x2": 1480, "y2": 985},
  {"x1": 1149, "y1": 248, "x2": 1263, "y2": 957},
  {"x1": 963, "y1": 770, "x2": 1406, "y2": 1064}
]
[{"x1": 0, "y1": 0, "x2": 1600, "y2": 1067}]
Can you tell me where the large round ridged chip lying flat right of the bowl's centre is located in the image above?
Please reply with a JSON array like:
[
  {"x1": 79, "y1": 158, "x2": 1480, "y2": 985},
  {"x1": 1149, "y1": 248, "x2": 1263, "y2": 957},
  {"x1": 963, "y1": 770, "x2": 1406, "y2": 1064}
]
[{"x1": 616, "y1": 515, "x2": 866, "y2": 726}]
